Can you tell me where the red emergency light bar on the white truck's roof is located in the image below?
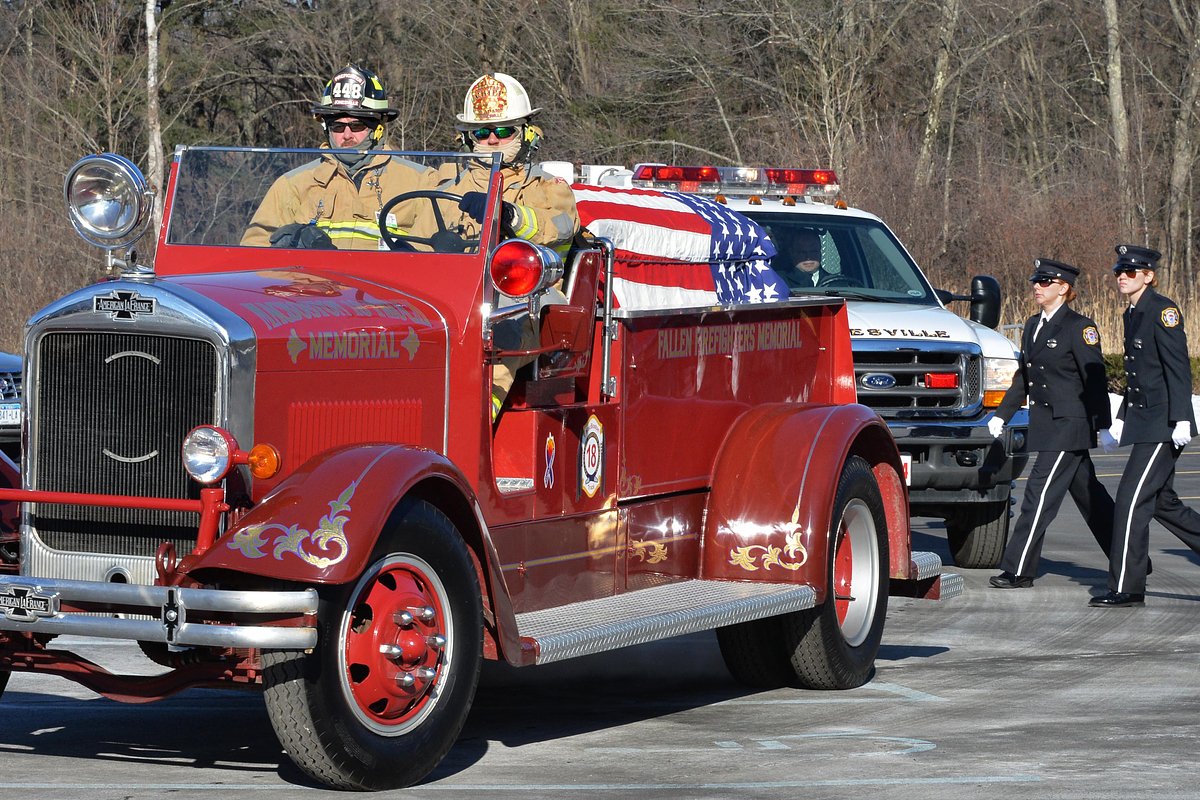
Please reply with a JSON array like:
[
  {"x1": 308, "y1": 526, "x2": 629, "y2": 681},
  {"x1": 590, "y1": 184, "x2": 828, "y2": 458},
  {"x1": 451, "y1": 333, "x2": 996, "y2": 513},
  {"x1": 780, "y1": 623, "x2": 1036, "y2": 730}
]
[{"x1": 632, "y1": 164, "x2": 841, "y2": 204}]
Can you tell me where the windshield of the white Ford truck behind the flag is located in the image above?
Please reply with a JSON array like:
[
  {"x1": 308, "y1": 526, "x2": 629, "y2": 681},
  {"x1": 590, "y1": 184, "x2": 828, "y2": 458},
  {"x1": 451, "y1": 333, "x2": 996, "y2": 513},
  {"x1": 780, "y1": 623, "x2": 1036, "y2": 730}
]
[{"x1": 744, "y1": 211, "x2": 938, "y2": 306}]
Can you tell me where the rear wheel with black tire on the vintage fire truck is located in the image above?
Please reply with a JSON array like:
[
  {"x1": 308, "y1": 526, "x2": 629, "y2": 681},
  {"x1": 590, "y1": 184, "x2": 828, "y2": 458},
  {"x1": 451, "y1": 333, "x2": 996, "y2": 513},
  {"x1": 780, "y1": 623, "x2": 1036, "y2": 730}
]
[{"x1": 782, "y1": 456, "x2": 888, "y2": 688}]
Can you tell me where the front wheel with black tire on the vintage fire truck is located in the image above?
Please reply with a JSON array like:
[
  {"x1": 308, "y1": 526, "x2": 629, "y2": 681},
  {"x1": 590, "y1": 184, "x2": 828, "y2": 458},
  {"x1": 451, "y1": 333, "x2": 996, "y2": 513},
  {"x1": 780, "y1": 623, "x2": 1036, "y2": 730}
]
[{"x1": 263, "y1": 500, "x2": 484, "y2": 790}]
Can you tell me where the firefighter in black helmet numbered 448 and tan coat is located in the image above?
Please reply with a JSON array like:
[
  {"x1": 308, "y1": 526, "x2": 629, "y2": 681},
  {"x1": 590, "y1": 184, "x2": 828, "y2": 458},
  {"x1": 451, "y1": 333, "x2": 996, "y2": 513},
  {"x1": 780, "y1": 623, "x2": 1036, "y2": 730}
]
[{"x1": 241, "y1": 65, "x2": 439, "y2": 249}]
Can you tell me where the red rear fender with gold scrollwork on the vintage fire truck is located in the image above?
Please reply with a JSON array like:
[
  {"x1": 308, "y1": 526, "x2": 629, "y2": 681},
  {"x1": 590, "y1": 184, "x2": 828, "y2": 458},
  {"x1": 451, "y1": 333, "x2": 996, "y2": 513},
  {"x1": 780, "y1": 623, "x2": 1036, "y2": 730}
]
[{"x1": 702, "y1": 404, "x2": 910, "y2": 602}]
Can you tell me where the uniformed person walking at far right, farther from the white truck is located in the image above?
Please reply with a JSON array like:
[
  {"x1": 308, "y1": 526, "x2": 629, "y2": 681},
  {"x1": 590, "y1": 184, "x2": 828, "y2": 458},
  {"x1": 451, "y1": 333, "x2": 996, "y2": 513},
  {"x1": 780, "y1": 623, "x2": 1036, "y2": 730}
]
[{"x1": 1088, "y1": 245, "x2": 1200, "y2": 608}]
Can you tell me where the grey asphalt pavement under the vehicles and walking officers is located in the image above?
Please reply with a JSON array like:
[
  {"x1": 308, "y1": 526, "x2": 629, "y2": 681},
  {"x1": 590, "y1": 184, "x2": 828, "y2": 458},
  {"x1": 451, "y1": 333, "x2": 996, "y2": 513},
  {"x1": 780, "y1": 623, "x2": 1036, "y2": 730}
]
[{"x1": 0, "y1": 444, "x2": 1200, "y2": 800}]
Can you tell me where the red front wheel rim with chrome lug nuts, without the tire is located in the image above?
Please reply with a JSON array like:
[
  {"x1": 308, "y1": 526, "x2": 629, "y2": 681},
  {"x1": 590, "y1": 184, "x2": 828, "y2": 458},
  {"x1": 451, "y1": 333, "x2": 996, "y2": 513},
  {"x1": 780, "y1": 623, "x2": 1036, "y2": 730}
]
[{"x1": 341, "y1": 554, "x2": 454, "y2": 735}]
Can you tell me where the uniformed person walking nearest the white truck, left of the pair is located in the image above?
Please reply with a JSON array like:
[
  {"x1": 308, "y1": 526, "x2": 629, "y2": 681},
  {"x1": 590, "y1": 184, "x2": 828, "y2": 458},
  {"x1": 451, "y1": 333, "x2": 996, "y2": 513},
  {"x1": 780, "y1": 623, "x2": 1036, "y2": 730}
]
[{"x1": 988, "y1": 258, "x2": 1112, "y2": 589}]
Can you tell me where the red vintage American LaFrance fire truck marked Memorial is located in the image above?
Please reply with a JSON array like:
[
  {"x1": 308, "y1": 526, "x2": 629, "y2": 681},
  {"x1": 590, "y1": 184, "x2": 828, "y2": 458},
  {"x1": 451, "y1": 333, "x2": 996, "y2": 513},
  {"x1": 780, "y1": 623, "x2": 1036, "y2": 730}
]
[{"x1": 0, "y1": 148, "x2": 961, "y2": 789}]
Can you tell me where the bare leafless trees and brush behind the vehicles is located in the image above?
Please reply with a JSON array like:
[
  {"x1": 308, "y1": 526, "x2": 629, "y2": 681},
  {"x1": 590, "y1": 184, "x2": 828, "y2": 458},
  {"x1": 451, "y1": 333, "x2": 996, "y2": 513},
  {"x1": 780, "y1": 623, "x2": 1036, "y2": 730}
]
[{"x1": 0, "y1": 0, "x2": 1200, "y2": 349}]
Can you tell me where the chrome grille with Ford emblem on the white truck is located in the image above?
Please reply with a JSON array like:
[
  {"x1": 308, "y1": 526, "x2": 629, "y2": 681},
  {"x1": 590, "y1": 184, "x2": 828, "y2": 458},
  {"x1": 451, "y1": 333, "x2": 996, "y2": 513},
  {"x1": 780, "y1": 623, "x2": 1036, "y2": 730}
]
[{"x1": 854, "y1": 342, "x2": 983, "y2": 420}]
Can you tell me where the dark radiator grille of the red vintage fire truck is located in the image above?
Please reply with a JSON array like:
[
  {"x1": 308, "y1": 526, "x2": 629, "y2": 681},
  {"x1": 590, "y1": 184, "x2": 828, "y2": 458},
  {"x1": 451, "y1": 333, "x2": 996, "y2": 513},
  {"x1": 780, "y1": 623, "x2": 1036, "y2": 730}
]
[{"x1": 28, "y1": 332, "x2": 217, "y2": 557}]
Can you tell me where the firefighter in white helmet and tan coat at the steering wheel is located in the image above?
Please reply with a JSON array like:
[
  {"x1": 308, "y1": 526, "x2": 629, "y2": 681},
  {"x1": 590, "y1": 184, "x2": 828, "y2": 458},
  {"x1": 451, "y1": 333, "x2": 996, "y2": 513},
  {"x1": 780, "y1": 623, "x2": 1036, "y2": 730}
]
[{"x1": 442, "y1": 72, "x2": 580, "y2": 420}]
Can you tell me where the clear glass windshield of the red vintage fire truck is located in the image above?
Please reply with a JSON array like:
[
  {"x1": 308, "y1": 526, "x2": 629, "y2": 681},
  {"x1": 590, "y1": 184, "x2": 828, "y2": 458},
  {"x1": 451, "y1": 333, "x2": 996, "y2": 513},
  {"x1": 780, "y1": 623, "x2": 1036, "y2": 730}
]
[{"x1": 167, "y1": 148, "x2": 498, "y2": 253}]
